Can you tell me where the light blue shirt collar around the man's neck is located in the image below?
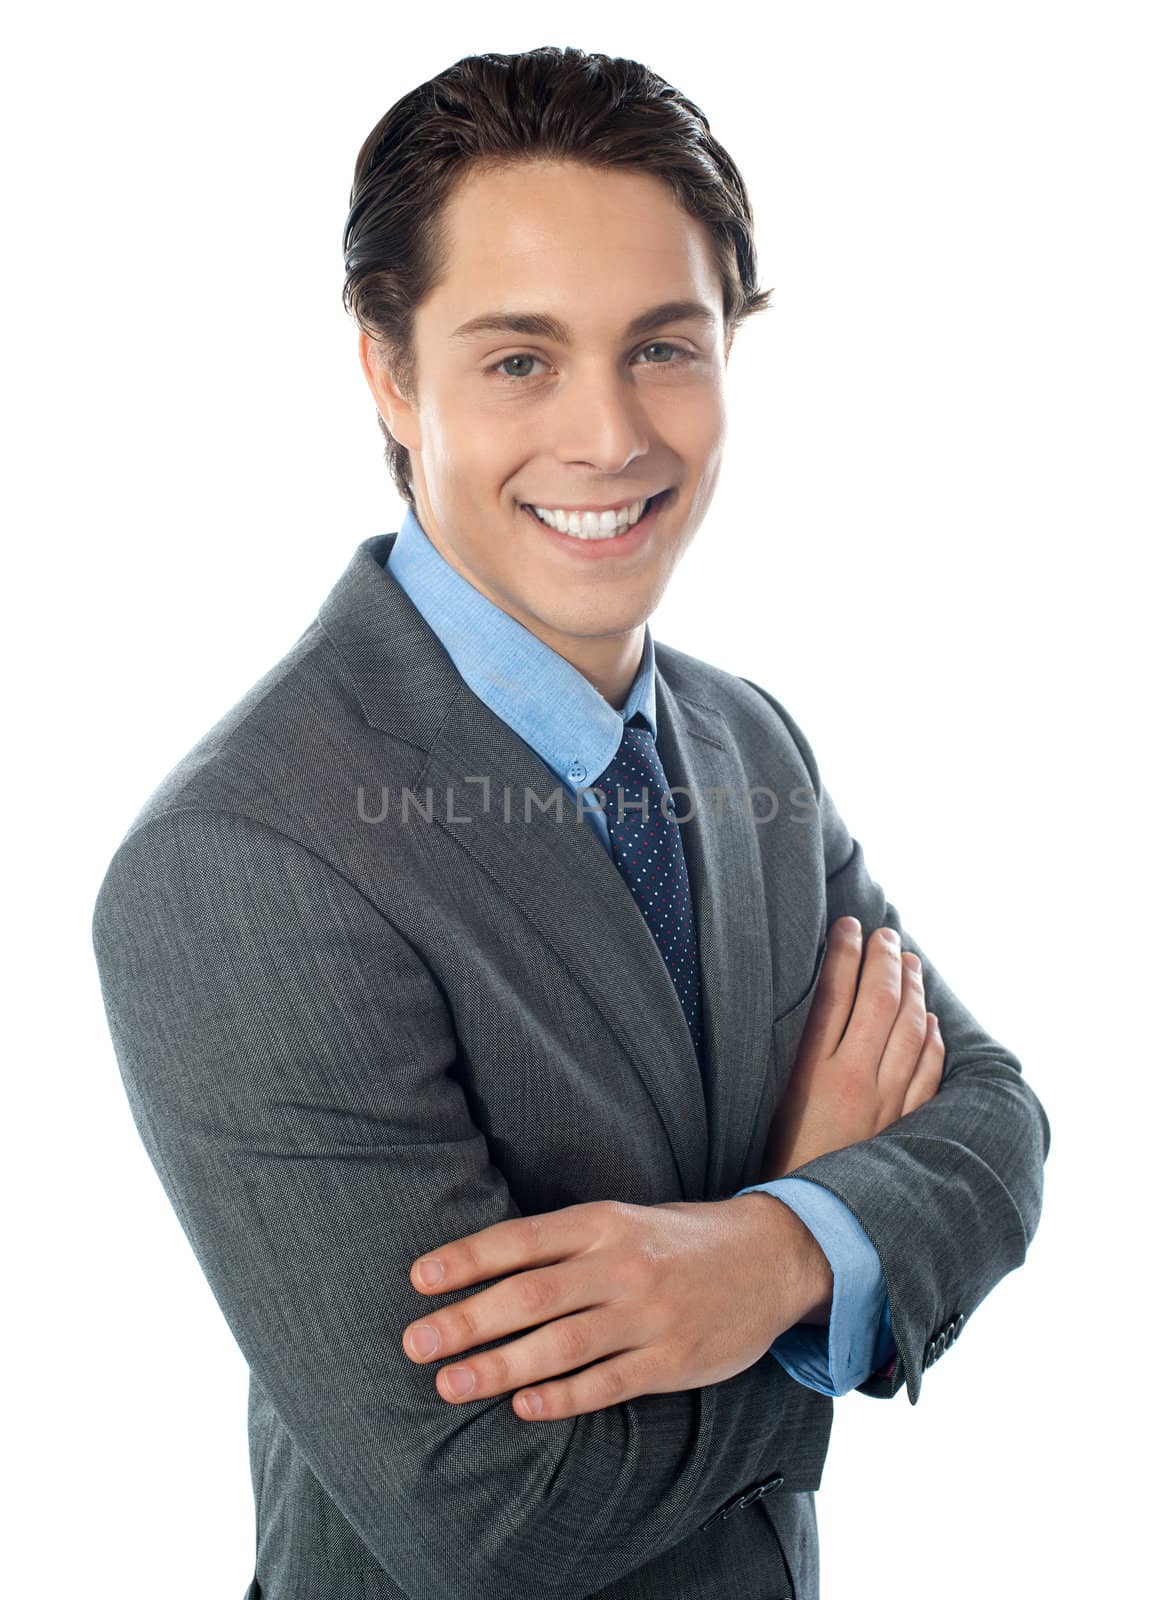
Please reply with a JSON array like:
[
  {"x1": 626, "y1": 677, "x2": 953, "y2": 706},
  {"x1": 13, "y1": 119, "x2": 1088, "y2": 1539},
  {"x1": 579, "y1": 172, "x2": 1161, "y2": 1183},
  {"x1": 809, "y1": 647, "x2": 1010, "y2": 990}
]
[{"x1": 386, "y1": 507, "x2": 658, "y2": 789}]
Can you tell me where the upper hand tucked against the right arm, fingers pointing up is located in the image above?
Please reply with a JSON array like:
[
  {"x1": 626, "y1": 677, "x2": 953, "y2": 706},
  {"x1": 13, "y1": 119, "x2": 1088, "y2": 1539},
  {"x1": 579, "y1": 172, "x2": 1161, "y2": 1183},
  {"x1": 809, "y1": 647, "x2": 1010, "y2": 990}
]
[{"x1": 757, "y1": 917, "x2": 946, "y2": 1182}]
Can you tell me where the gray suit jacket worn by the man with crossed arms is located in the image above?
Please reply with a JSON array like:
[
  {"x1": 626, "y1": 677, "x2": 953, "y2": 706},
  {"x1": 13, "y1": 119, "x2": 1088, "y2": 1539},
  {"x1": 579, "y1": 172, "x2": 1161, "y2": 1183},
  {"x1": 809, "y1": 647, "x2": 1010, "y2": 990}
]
[{"x1": 93, "y1": 534, "x2": 1050, "y2": 1600}]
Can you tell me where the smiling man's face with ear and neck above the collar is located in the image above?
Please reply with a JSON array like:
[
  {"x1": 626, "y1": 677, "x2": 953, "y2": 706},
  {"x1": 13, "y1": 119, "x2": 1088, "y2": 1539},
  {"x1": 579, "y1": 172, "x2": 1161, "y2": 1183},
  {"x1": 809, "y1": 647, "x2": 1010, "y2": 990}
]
[{"x1": 362, "y1": 162, "x2": 726, "y2": 682}]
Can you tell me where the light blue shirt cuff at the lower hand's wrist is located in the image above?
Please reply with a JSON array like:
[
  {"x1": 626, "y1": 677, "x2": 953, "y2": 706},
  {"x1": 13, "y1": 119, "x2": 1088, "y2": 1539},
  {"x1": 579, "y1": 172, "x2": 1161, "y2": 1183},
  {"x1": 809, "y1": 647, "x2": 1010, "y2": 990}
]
[{"x1": 738, "y1": 1178, "x2": 890, "y2": 1397}]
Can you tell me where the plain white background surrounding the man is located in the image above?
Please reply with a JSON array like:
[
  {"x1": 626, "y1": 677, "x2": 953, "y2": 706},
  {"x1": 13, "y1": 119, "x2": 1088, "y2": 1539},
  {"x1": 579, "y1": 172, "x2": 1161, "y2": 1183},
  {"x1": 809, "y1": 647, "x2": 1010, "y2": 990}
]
[{"x1": 2, "y1": 0, "x2": 1168, "y2": 1600}]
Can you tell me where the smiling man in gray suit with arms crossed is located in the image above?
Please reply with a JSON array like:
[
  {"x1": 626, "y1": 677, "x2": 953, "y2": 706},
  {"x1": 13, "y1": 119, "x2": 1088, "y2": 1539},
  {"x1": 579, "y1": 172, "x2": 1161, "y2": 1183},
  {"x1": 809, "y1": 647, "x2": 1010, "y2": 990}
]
[{"x1": 94, "y1": 48, "x2": 1050, "y2": 1600}]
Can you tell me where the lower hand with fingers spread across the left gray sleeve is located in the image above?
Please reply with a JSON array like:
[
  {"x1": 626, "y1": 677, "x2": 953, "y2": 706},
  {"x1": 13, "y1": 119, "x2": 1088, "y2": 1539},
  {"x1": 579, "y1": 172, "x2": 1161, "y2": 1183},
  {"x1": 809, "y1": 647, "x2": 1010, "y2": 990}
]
[{"x1": 402, "y1": 1194, "x2": 830, "y2": 1422}]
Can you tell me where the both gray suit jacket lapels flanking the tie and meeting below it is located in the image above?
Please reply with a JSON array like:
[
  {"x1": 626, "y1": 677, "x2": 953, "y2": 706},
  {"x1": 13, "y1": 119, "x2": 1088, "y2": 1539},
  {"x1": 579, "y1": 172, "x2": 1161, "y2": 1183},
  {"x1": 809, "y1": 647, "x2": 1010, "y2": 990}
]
[{"x1": 320, "y1": 534, "x2": 771, "y2": 1200}]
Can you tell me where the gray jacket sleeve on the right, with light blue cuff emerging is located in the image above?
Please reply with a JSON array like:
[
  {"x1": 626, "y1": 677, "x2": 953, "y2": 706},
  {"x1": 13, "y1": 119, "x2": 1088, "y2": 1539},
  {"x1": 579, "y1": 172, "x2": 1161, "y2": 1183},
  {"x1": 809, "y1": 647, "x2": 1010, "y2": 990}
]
[{"x1": 742, "y1": 678, "x2": 1050, "y2": 1405}]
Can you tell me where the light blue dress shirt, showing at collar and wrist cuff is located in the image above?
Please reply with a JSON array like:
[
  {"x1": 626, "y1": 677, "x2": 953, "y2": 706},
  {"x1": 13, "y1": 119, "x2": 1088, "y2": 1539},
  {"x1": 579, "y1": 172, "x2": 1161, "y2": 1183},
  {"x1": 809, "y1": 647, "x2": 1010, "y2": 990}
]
[{"x1": 386, "y1": 509, "x2": 896, "y2": 1395}]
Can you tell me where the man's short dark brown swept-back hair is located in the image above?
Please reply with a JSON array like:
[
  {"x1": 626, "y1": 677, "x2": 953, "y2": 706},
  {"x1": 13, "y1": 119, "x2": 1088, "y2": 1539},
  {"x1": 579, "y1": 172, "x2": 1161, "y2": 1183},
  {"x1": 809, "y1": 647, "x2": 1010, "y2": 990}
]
[{"x1": 342, "y1": 45, "x2": 773, "y2": 506}]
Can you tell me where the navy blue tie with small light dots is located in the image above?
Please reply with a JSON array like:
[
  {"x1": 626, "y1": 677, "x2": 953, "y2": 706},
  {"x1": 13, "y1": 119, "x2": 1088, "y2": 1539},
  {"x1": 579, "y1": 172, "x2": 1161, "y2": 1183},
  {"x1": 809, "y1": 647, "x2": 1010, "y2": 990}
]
[{"x1": 590, "y1": 712, "x2": 702, "y2": 1064}]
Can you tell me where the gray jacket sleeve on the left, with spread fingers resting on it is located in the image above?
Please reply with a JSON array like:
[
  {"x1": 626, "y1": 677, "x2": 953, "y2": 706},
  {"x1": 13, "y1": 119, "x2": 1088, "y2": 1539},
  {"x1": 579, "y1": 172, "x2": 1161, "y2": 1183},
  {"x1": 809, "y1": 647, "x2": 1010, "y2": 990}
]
[{"x1": 93, "y1": 808, "x2": 830, "y2": 1600}]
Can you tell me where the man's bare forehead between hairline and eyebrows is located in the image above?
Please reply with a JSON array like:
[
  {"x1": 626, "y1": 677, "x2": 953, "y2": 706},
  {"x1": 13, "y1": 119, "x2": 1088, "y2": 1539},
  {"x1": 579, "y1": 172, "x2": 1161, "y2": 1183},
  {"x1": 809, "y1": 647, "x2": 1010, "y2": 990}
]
[{"x1": 419, "y1": 160, "x2": 722, "y2": 333}]
